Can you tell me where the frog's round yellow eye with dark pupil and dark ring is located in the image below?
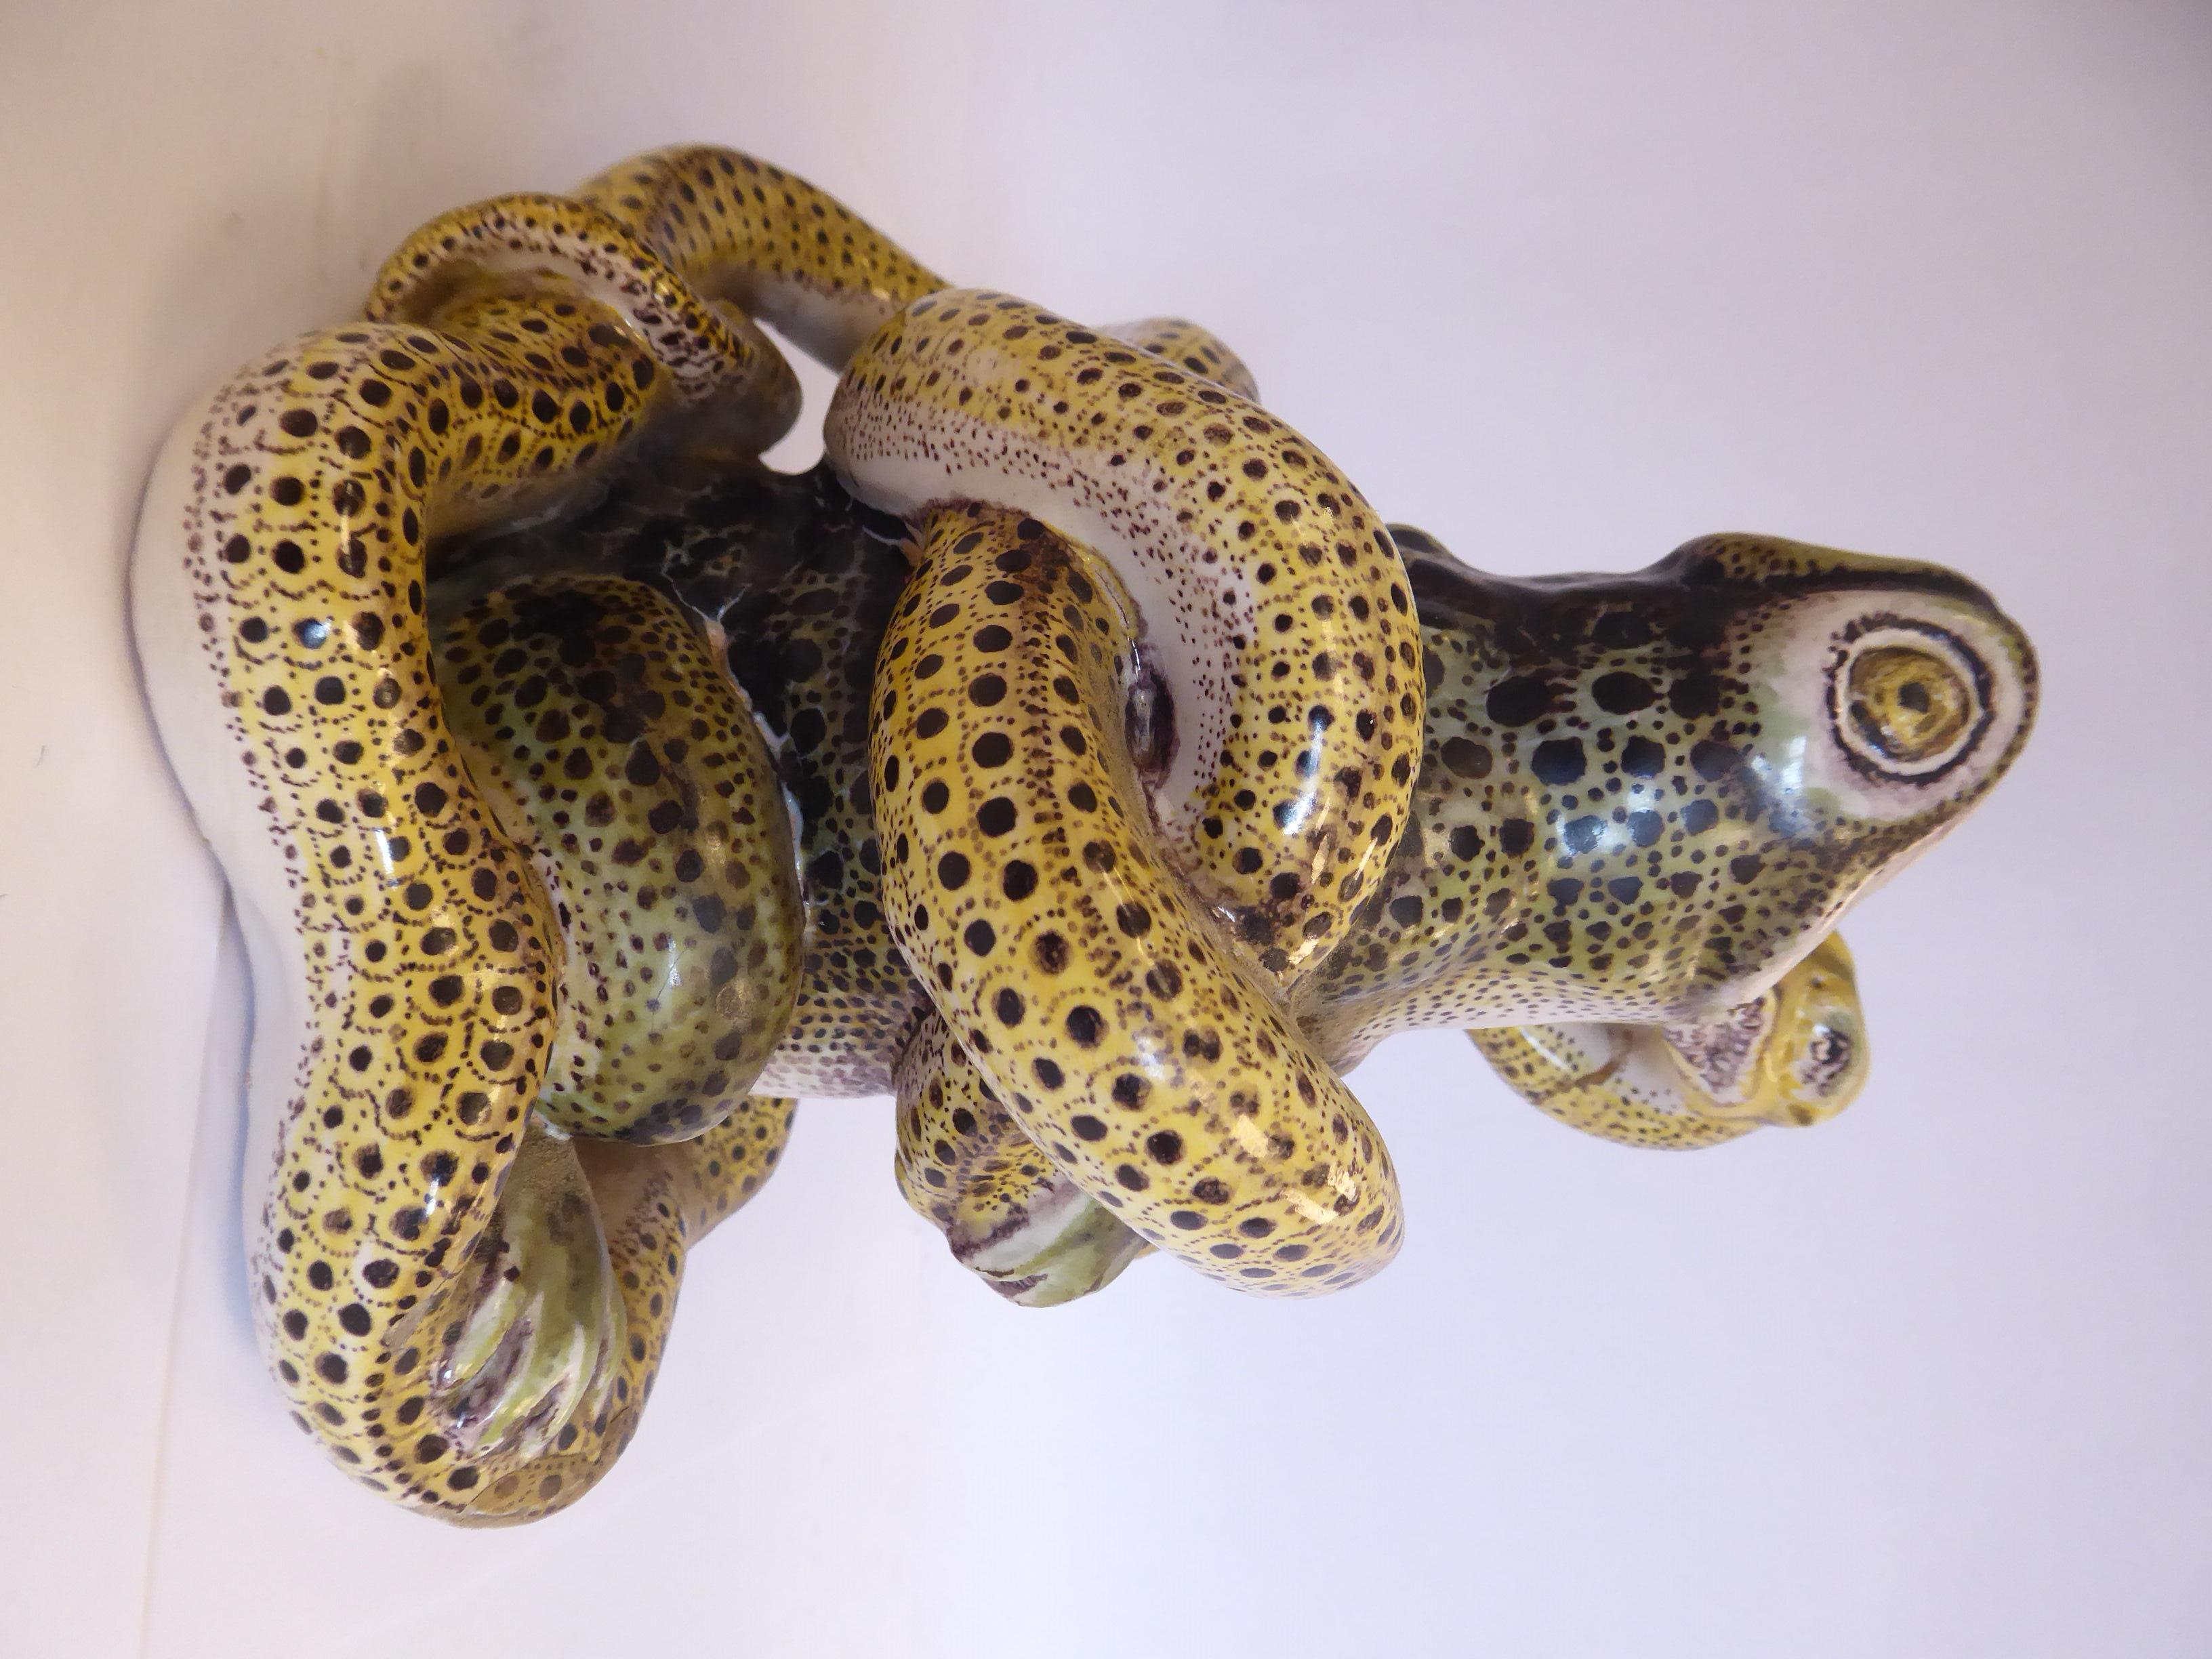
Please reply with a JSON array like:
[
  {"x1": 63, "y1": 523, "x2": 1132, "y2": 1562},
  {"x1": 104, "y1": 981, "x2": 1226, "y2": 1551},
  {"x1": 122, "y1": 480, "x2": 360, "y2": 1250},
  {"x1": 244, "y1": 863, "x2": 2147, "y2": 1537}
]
[{"x1": 1829, "y1": 619, "x2": 1988, "y2": 783}]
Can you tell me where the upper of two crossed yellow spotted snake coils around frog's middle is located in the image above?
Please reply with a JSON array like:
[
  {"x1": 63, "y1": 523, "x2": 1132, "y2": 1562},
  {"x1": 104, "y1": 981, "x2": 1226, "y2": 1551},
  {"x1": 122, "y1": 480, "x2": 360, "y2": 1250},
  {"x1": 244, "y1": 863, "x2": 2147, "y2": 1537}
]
[{"x1": 825, "y1": 292, "x2": 1420, "y2": 973}]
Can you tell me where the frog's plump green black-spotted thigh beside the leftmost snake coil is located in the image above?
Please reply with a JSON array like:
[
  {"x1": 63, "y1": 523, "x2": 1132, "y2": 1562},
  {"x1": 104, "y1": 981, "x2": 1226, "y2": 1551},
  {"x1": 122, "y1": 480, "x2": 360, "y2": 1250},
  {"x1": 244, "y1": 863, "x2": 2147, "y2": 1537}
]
[{"x1": 438, "y1": 575, "x2": 805, "y2": 1141}]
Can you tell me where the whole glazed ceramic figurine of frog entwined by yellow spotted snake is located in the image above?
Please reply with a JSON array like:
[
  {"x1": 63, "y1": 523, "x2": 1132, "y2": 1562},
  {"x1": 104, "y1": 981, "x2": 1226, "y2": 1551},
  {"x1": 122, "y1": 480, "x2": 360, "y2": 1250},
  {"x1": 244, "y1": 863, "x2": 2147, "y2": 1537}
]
[{"x1": 133, "y1": 148, "x2": 2035, "y2": 1522}]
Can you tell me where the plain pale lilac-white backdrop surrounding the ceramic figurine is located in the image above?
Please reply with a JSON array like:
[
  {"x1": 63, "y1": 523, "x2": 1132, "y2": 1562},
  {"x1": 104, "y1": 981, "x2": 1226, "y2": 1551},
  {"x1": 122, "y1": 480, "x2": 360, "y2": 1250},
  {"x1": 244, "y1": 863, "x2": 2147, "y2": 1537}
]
[{"x1": 0, "y1": 0, "x2": 2212, "y2": 1659}]
